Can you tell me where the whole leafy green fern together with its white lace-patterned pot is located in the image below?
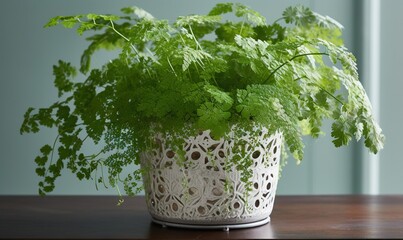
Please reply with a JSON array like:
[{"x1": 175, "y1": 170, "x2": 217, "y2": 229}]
[{"x1": 21, "y1": 3, "x2": 384, "y2": 230}]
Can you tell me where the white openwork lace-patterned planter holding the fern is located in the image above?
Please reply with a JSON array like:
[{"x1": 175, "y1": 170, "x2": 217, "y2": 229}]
[{"x1": 141, "y1": 127, "x2": 282, "y2": 229}]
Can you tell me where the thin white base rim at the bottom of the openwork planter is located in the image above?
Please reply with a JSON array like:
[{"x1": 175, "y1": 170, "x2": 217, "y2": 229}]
[{"x1": 152, "y1": 217, "x2": 270, "y2": 232}]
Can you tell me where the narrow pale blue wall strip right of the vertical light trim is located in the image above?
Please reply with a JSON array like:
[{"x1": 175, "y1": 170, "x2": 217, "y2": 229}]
[{"x1": 380, "y1": 0, "x2": 403, "y2": 194}]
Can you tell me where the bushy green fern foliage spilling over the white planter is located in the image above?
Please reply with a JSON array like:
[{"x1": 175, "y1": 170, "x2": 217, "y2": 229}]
[{"x1": 21, "y1": 3, "x2": 384, "y2": 197}]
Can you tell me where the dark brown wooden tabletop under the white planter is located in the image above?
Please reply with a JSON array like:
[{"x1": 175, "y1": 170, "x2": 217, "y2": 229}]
[{"x1": 0, "y1": 195, "x2": 403, "y2": 240}]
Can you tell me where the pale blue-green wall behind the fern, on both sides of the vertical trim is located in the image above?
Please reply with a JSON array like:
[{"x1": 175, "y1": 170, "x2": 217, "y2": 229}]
[{"x1": 0, "y1": 0, "x2": 403, "y2": 195}]
